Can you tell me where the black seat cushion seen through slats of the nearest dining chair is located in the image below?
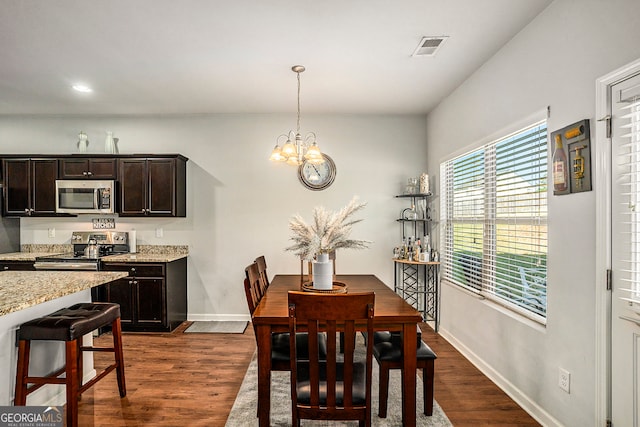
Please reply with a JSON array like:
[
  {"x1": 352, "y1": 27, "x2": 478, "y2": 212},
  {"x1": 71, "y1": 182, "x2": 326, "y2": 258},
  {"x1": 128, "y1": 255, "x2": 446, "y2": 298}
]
[{"x1": 297, "y1": 362, "x2": 367, "y2": 406}]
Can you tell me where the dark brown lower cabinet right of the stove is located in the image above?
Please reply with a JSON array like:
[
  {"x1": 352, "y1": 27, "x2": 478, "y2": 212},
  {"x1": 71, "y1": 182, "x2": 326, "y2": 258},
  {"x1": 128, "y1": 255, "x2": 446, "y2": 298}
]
[{"x1": 93, "y1": 258, "x2": 187, "y2": 332}]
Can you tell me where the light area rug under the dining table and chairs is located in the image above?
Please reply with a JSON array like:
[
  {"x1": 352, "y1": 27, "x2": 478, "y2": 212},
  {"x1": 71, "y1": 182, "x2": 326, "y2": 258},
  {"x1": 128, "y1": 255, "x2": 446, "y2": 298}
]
[{"x1": 226, "y1": 343, "x2": 452, "y2": 427}]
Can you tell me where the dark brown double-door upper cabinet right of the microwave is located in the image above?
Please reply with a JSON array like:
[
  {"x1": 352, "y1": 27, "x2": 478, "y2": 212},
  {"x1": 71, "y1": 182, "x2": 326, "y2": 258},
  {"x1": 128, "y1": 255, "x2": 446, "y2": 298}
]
[{"x1": 118, "y1": 156, "x2": 187, "y2": 217}]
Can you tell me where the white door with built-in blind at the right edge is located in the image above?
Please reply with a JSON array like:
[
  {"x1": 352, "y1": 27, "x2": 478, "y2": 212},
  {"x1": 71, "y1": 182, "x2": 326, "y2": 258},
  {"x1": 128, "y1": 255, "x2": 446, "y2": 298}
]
[{"x1": 610, "y1": 75, "x2": 640, "y2": 427}]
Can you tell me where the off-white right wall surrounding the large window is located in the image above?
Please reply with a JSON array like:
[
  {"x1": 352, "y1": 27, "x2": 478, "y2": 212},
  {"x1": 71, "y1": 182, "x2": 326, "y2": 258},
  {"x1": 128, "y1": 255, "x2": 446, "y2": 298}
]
[{"x1": 427, "y1": 0, "x2": 640, "y2": 426}]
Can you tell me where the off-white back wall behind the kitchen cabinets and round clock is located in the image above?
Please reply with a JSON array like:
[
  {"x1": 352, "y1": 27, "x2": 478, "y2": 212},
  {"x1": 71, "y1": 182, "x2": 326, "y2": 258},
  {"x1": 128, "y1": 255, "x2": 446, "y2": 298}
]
[{"x1": 0, "y1": 114, "x2": 426, "y2": 320}]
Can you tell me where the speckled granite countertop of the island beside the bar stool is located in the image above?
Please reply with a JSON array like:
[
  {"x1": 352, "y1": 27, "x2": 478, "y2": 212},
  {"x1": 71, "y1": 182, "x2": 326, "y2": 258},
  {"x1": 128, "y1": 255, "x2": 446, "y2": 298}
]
[{"x1": 0, "y1": 271, "x2": 129, "y2": 316}]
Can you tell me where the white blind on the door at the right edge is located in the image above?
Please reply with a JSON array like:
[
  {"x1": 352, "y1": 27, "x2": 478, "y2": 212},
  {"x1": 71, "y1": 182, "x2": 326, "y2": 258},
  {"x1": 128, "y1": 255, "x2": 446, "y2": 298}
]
[{"x1": 618, "y1": 98, "x2": 640, "y2": 301}]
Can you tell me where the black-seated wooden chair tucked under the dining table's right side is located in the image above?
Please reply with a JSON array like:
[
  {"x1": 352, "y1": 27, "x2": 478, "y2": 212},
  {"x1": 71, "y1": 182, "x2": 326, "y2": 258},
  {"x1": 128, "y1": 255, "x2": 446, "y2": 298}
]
[{"x1": 373, "y1": 329, "x2": 437, "y2": 418}]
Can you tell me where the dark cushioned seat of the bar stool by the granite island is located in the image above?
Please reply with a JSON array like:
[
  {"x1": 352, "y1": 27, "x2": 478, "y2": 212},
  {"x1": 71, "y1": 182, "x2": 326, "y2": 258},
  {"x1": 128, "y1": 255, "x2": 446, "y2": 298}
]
[{"x1": 18, "y1": 303, "x2": 120, "y2": 341}]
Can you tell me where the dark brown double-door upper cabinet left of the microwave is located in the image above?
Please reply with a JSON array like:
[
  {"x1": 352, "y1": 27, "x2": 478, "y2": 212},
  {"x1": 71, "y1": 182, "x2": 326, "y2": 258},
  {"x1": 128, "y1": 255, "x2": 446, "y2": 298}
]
[{"x1": 2, "y1": 158, "x2": 58, "y2": 216}]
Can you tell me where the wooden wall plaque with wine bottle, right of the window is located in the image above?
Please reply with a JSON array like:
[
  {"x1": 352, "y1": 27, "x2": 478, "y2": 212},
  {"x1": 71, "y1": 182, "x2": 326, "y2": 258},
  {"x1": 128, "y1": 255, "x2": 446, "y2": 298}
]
[{"x1": 551, "y1": 119, "x2": 591, "y2": 195}]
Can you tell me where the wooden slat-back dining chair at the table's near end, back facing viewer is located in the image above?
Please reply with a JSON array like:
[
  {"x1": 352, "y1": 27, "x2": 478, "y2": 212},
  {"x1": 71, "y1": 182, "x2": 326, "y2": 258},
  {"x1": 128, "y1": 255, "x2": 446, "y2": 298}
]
[{"x1": 288, "y1": 291, "x2": 375, "y2": 427}]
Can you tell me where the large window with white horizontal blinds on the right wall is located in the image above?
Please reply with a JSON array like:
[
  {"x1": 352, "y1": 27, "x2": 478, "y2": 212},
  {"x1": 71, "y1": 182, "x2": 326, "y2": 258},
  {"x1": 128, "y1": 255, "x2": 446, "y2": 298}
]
[{"x1": 440, "y1": 122, "x2": 547, "y2": 318}]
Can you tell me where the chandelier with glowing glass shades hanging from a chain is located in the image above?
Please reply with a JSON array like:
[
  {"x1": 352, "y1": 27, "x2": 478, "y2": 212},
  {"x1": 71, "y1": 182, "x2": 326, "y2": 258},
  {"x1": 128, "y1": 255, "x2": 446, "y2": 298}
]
[{"x1": 269, "y1": 65, "x2": 324, "y2": 166}]
